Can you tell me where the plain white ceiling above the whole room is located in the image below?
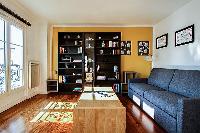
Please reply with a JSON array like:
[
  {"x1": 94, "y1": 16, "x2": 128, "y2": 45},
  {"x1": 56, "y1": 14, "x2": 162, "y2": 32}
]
[{"x1": 13, "y1": 0, "x2": 191, "y2": 25}]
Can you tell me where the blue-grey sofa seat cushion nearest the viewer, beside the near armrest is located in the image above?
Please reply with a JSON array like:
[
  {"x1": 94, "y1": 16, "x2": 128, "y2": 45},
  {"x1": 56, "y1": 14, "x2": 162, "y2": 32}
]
[{"x1": 144, "y1": 90, "x2": 185, "y2": 118}]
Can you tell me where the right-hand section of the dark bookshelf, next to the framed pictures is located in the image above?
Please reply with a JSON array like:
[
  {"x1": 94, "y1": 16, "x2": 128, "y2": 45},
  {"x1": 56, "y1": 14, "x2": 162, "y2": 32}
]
[{"x1": 95, "y1": 32, "x2": 121, "y2": 86}]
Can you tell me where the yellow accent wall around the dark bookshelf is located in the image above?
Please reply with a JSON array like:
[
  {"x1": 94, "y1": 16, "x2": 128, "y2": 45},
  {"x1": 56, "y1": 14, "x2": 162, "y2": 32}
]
[{"x1": 52, "y1": 27, "x2": 153, "y2": 79}]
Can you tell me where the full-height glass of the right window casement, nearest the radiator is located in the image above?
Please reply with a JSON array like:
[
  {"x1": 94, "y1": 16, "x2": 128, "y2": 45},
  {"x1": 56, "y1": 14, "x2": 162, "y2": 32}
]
[{"x1": 10, "y1": 25, "x2": 23, "y2": 89}]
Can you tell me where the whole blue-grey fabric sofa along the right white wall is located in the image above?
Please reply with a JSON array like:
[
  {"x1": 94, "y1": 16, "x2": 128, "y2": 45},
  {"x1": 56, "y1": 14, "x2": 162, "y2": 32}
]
[{"x1": 128, "y1": 68, "x2": 200, "y2": 133}]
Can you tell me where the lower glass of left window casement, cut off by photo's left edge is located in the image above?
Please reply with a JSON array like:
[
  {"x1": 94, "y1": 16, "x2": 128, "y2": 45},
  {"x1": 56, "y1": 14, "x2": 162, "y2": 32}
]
[{"x1": 0, "y1": 41, "x2": 6, "y2": 93}]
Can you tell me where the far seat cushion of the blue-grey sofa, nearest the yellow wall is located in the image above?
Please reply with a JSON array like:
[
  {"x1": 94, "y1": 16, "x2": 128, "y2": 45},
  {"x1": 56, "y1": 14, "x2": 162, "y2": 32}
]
[{"x1": 130, "y1": 83, "x2": 162, "y2": 97}]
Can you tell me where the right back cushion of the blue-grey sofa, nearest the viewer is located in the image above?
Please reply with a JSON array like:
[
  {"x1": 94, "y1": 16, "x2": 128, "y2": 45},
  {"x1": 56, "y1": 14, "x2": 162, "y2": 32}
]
[{"x1": 169, "y1": 70, "x2": 200, "y2": 98}]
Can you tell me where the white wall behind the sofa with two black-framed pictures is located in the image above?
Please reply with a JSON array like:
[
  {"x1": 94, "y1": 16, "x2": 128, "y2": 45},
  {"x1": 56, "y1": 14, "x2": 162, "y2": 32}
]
[{"x1": 153, "y1": 0, "x2": 200, "y2": 69}]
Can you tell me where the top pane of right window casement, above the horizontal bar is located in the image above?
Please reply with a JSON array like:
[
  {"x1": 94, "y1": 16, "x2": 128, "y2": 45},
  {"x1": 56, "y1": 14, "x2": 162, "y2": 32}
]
[{"x1": 10, "y1": 25, "x2": 23, "y2": 46}]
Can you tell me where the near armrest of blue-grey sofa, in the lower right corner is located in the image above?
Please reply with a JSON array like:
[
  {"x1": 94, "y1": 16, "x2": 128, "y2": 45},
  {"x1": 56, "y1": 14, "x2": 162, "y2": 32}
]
[{"x1": 177, "y1": 98, "x2": 200, "y2": 133}]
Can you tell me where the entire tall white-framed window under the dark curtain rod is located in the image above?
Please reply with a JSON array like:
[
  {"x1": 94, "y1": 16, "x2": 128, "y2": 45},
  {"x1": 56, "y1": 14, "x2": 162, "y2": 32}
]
[{"x1": 0, "y1": 18, "x2": 24, "y2": 94}]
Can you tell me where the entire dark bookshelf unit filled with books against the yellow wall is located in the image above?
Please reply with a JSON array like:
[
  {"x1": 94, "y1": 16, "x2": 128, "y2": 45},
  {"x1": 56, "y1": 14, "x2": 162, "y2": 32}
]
[{"x1": 58, "y1": 32, "x2": 121, "y2": 92}]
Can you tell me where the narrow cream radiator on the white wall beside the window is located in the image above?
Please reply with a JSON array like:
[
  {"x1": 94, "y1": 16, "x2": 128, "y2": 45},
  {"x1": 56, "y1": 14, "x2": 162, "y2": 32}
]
[{"x1": 28, "y1": 61, "x2": 40, "y2": 88}]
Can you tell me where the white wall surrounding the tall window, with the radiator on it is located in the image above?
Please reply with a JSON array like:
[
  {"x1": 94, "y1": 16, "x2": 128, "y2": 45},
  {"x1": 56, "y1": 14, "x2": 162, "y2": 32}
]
[{"x1": 0, "y1": 0, "x2": 48, "y2": 112}]
